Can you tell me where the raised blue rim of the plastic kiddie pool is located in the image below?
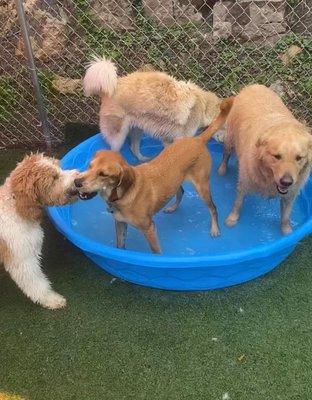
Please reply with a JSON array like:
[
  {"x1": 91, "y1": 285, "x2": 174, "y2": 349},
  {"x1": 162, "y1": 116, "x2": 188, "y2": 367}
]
[{"x1": 46, "y1": 134, "x2": 312, "y2": 268}]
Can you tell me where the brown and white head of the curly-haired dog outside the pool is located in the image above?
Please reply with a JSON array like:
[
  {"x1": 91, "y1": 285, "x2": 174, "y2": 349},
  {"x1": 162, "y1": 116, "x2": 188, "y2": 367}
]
[{"x1": 9, "y1": 154, "x2": 78, "y2": 219}]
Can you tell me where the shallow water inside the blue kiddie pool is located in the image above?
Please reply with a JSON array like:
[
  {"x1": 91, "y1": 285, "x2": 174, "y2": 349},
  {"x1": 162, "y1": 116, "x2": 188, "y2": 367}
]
[{"x1": 70, "y1": 138, "x2": 307, "y2": 256}]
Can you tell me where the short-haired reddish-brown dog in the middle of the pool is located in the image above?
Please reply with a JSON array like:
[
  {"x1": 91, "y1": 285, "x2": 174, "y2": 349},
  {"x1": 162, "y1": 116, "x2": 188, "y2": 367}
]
[{"x1": 75, "y1": 98, "x2": 232, "y2": 253}]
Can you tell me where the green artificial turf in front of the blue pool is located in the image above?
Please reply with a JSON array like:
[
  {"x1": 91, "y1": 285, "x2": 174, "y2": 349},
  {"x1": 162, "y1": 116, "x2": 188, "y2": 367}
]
[{"x1": 0, "y1": 142, "x2": 312, "y2": 400}]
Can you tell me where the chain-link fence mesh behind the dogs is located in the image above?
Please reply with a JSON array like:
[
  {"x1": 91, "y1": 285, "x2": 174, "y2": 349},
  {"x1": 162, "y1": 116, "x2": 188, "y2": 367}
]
[{"x1": 0, "y1": 0, "x2": 312, "y2": 147}]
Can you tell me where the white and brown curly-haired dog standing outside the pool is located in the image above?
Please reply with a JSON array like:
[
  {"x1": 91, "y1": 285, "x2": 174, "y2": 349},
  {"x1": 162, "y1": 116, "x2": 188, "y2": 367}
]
[{"x1": 0, "y1": 154, "x2": 78, "y2": 309}]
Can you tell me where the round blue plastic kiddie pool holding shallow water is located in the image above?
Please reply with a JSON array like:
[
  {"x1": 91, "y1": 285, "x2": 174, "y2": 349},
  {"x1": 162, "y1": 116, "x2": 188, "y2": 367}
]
[{"x1": 48, "y1": 135, "x2": 312, "y2": 290}]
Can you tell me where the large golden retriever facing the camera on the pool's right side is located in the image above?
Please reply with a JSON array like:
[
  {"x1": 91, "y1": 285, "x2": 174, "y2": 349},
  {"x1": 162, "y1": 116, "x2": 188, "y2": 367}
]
[{"x1": 219, "y1": 85, "x2": 312, "y2": 234}]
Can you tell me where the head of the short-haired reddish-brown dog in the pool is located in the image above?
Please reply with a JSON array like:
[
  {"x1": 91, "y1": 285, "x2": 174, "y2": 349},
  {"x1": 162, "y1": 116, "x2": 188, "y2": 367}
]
[{"x1": 75, "y1": 150, "x2": 133, "y2": 201}]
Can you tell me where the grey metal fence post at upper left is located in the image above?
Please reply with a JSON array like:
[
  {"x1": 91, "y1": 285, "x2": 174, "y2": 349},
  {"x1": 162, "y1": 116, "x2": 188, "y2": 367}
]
[{"x1": 15, "y1": 0, "x2": 51, "y2": 150}]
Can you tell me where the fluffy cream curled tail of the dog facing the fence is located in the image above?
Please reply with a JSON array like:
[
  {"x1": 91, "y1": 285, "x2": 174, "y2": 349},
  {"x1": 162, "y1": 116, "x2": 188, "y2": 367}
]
[{"x1": 83, "y1": 57, "x2": 118, "y2": 97}]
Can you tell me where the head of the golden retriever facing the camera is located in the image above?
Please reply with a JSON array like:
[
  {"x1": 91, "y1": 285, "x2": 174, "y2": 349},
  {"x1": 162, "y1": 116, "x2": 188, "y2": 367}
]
[{"x1": 257, "y1": 125, "x2": 312, "y2": 194}]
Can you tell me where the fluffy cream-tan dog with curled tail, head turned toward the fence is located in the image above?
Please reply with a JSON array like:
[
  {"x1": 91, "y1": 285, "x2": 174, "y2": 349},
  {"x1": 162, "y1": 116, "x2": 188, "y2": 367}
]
[{"x1": 84, "y1": 59, "x2": 221, "y2": 160}]
